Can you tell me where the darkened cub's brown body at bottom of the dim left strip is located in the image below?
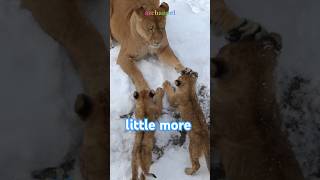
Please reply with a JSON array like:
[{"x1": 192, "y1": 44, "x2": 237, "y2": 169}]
[{"x1": 80, "y1": 93, "x2": 109, "y2": 180}]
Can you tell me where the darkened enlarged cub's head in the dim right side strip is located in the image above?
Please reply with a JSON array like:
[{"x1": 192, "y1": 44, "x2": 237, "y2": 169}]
[{"x1": 211, "y1": 37, "x2": 279, "y2": 90}]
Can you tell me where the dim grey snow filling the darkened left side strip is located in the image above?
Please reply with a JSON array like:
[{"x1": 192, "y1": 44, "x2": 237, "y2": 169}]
[{"x1": 0, "y1": 0, "x2": 106, "y2": 180}]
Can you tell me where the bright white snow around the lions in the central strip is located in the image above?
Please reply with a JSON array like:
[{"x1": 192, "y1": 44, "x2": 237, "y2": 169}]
[{"x1": 110, "y1": 0, "x2": 210, "y2": 180}]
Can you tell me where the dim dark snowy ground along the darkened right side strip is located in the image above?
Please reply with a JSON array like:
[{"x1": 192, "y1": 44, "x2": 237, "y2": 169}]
[{"x1": 213, "y1": 0, "x2": 320, "y2": 180}]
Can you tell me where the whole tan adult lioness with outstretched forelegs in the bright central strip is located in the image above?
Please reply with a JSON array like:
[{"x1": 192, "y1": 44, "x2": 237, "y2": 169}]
[{"x1": 110, "y1": 0, "x2": 184, "y2": 91}]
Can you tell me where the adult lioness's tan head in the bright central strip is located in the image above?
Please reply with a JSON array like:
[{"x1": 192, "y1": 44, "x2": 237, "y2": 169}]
[{"x1": 132, "y1": 3, "x2": 169, "y2": 48}]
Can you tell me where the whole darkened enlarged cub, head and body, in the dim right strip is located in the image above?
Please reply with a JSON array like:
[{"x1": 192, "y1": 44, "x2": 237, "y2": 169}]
[{"x1": 212, "y1": 39, "x2": 303, "y2": 180}]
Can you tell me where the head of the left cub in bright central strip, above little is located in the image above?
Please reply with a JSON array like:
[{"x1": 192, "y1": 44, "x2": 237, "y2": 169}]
[{"x1": 133, "y1": 90, "x2": 156, "y2": 119}]
